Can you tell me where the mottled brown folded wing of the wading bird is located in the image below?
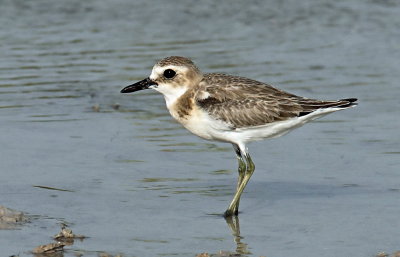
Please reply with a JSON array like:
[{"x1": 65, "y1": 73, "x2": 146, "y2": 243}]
[{"x1": 196, "y1": 74, "x2": 357, "y2": 128}]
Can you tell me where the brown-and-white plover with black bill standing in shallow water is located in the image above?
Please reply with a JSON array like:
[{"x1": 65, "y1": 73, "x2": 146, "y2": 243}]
[{"x1": 121, "y1": 56, "x2": 357, "y2": 218}]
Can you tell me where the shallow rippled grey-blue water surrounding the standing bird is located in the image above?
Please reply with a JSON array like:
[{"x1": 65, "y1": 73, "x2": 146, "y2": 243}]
[{"x1": 0, "y1": 0, "x2": 400, "y2": 257}]
